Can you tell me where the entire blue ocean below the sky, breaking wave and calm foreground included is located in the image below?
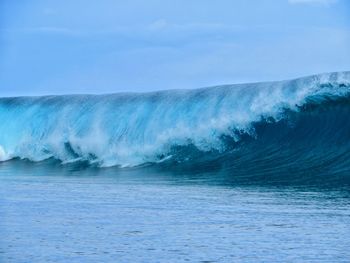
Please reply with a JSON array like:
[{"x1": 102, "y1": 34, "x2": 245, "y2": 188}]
[{"x1": 0, "y1": 72, "x2": 350, "y2": 262}]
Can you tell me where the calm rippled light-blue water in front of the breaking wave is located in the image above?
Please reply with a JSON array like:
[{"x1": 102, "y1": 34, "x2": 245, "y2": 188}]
[{"x1": 0, "y1": 162, "x2": 350, "y2": 262}]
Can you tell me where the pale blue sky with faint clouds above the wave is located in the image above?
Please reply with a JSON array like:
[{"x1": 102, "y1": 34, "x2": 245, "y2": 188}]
[{"x1": 0, "y1": 0, "x2": 350, "y2": 97}]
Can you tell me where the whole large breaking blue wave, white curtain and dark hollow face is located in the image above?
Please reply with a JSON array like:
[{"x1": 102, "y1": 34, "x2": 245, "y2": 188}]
[{"x1": 0, "y1": 72, "x2": 350, "y2": 173}]
